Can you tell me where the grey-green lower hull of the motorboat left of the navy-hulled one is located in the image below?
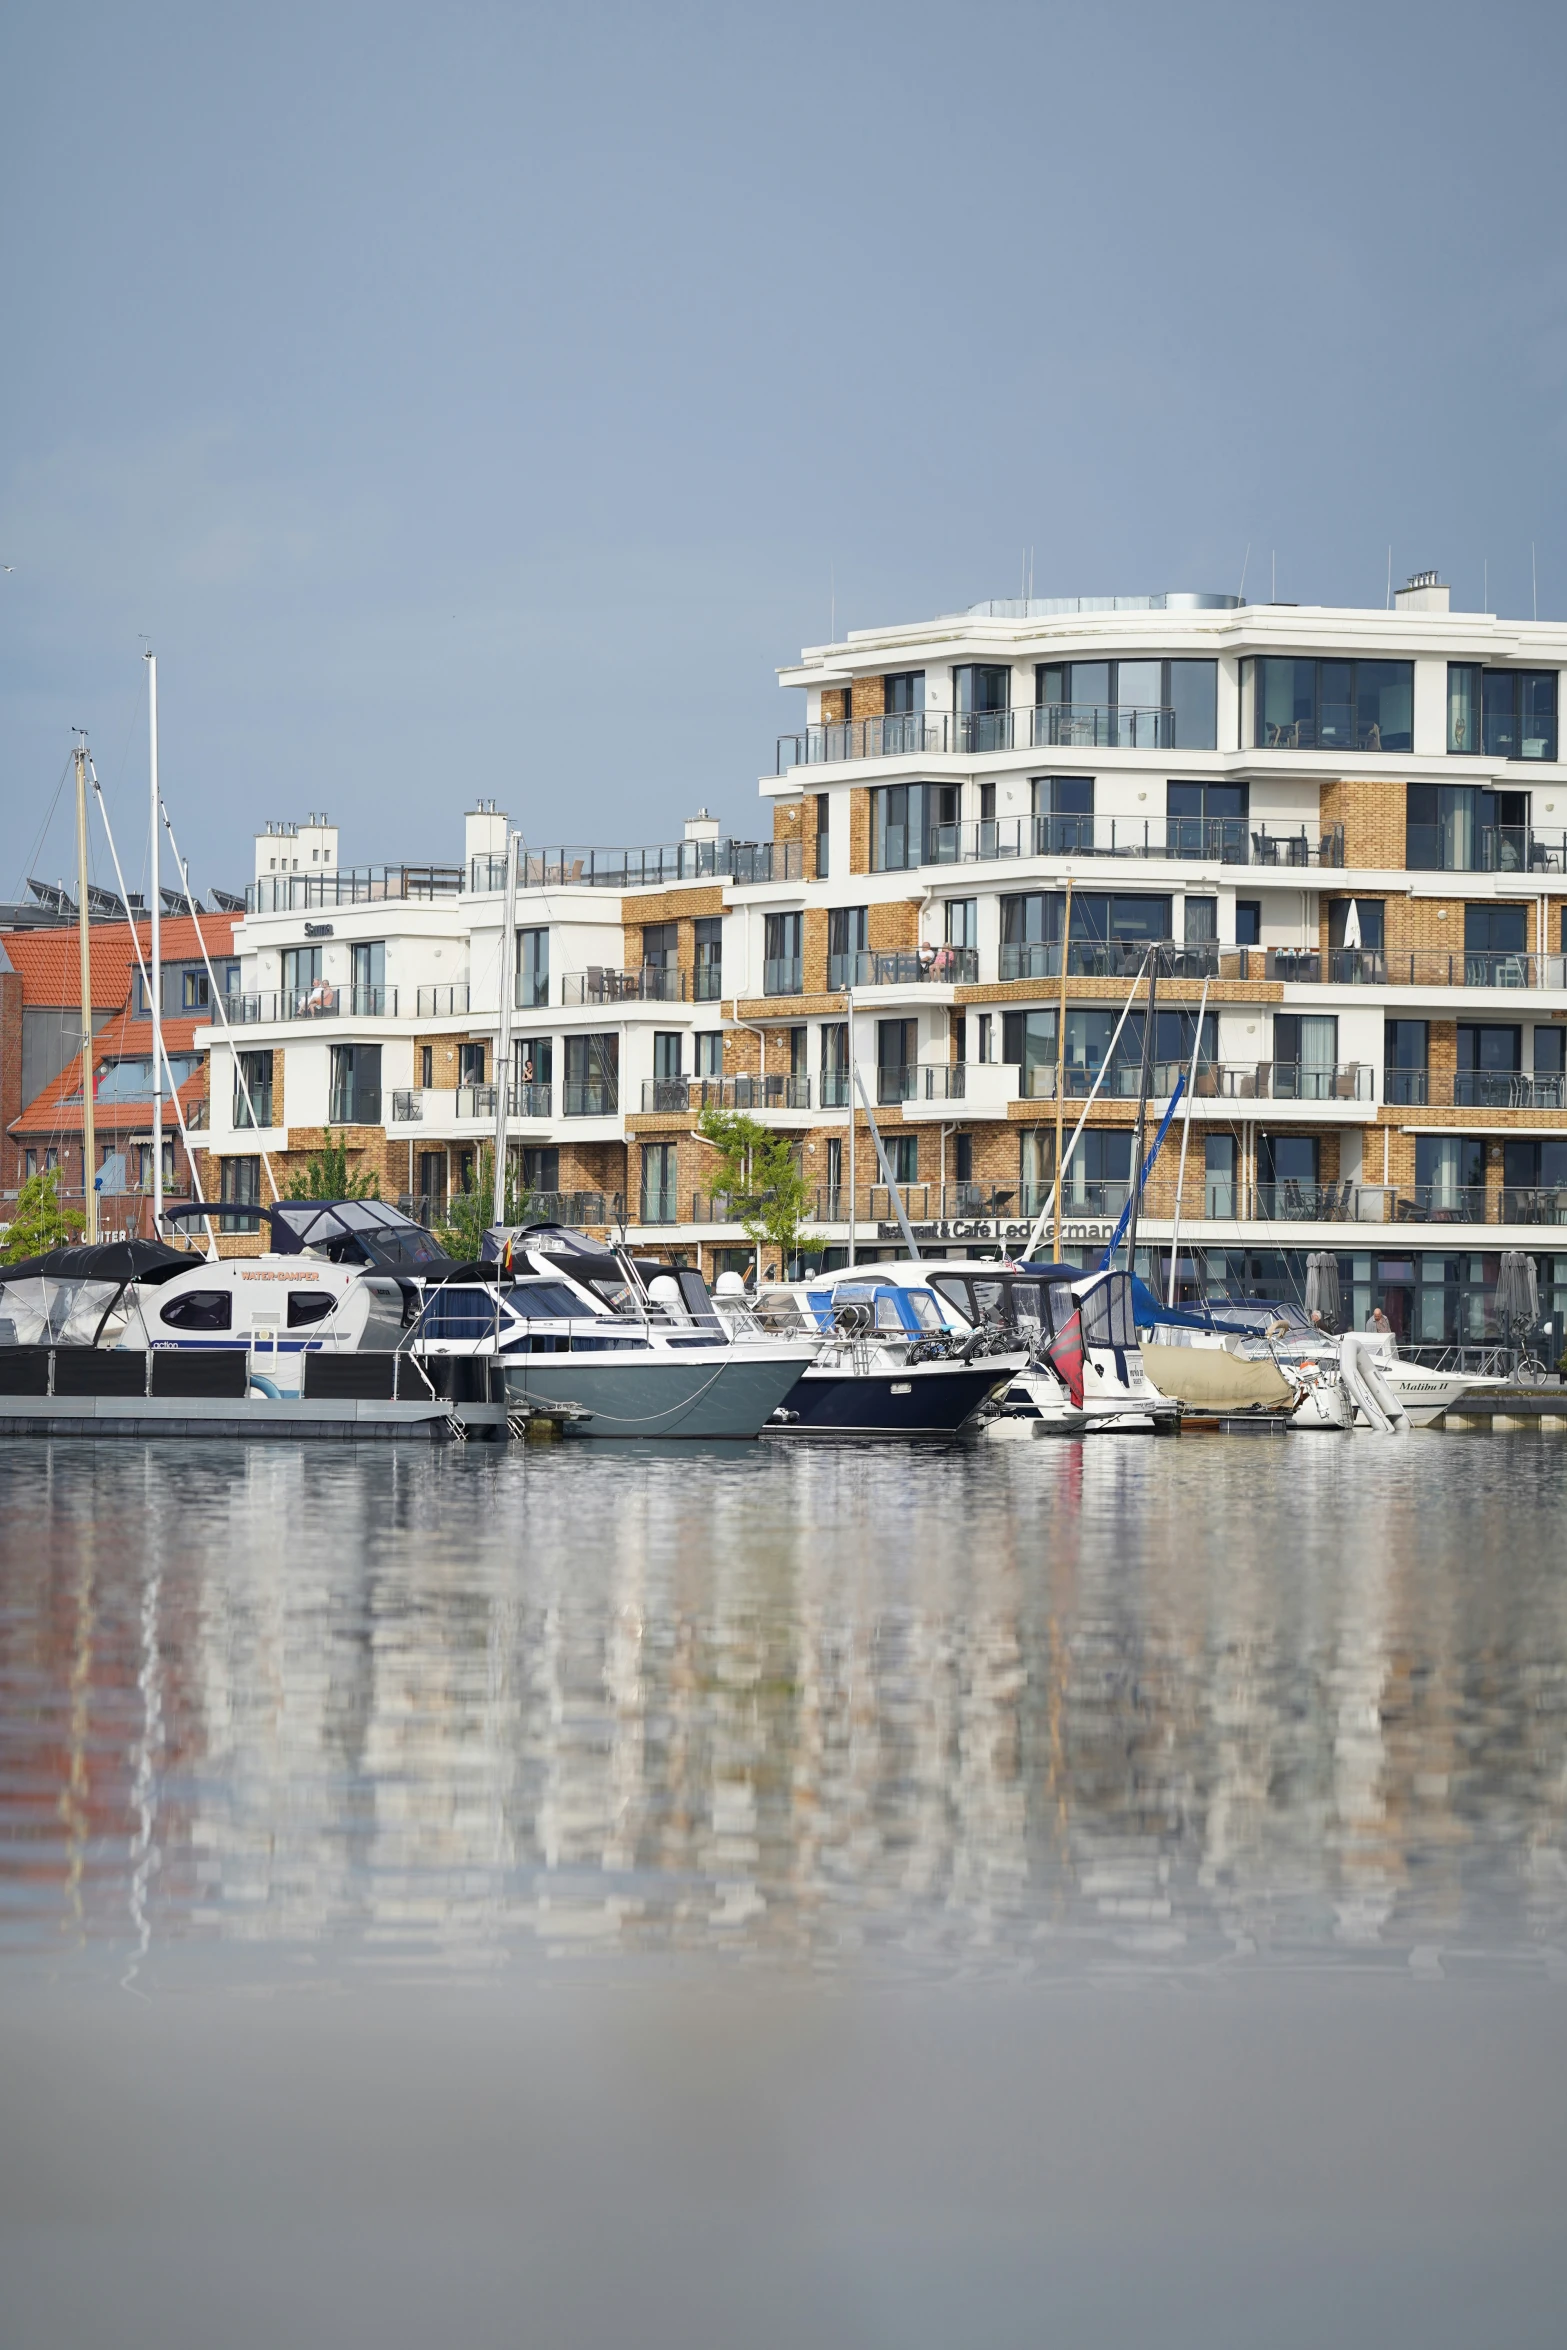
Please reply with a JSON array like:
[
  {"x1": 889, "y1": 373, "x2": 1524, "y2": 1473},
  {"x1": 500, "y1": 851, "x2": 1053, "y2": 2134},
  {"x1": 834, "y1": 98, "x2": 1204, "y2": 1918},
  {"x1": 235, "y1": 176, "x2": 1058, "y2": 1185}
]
[{"x1": 505, "y1": 1349, "x2": 801, "y2": 1441}]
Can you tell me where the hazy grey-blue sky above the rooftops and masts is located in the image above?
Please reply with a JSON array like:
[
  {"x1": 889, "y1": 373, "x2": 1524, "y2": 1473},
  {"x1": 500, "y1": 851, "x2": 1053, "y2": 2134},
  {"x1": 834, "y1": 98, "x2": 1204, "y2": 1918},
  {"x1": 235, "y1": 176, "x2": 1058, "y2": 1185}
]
[{"x1": 0, "y1": 0, "x2": 1567, "y2": 898}]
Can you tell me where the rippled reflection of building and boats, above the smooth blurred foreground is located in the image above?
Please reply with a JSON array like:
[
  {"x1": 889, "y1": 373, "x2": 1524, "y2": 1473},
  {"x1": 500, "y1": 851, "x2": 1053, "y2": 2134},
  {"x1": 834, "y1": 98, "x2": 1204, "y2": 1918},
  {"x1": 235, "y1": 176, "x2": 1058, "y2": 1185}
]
[{"x1": 0, "y1": 1438, "x2": 1567, "y2": 1981}]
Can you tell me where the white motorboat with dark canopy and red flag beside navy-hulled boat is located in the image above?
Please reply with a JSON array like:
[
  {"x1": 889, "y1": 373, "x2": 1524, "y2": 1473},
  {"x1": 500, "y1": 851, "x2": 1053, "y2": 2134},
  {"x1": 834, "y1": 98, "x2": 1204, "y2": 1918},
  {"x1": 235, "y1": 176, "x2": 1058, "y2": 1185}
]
[{"x1": 834, "y1": 1257, "x2": 1182, "y2": 1436}]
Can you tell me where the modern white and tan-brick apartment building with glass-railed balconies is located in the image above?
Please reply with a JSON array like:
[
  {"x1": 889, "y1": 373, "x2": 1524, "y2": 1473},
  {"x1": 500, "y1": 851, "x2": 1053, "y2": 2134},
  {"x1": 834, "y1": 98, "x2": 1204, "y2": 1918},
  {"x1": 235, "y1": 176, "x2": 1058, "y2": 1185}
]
[{"x1": 207, "y1": 576, "x2": 1567, "y2": 1340}]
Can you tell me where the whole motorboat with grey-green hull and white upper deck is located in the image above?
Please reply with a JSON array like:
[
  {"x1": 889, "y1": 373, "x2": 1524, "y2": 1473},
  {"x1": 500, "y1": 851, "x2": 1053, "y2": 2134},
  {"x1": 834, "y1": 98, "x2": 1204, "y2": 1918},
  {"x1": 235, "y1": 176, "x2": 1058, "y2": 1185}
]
[{"x1": 444, "y1": 1224, "x2": 815, "y2": 1441}]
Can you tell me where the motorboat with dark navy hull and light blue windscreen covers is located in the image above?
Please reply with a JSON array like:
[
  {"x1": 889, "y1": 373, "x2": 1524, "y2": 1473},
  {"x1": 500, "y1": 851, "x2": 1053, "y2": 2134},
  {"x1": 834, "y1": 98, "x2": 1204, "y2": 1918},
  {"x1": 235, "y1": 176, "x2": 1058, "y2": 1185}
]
[{"x1": 742, "y1": 1267, "x2": 1029, "y2": 1443}]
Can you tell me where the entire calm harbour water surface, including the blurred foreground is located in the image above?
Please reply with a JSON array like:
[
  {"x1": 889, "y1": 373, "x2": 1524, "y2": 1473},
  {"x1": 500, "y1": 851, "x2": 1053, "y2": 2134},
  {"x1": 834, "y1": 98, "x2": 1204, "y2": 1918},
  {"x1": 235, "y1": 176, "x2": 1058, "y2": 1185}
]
[{"x1": 0, "y1": 1436, "x2": 1567, "y2": 2350}]
